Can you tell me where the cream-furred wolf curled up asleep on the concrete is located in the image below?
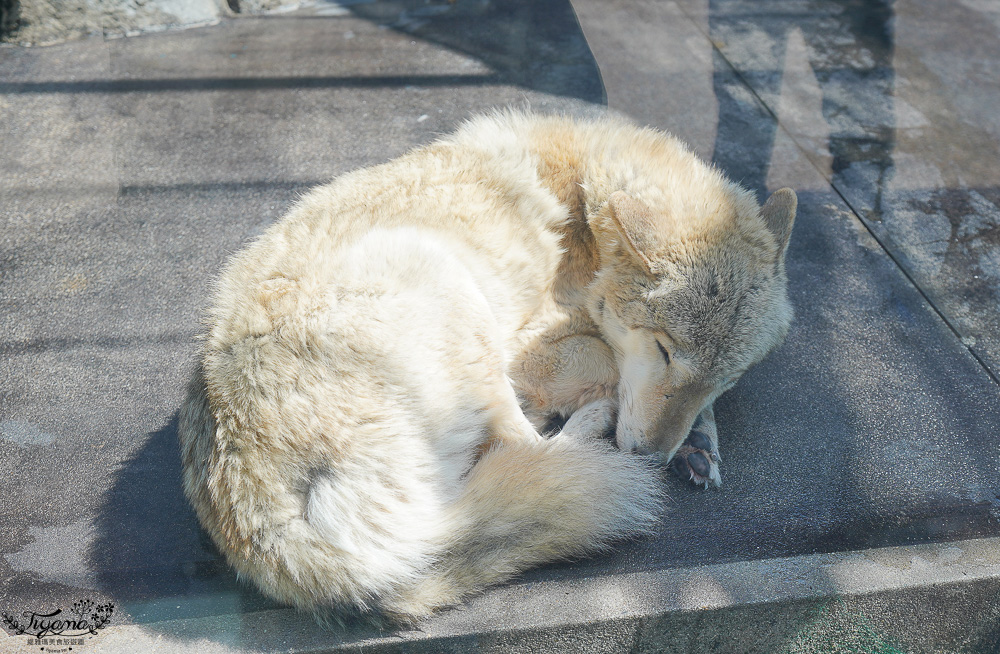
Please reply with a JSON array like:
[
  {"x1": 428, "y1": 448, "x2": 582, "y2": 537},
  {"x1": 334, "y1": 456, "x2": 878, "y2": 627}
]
[{"x1": 179, "y1": 113, "x2": 795, "y2": 620}]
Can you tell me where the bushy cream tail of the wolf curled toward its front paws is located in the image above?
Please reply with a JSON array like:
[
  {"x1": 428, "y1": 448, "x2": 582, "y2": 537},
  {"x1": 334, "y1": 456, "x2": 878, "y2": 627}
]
[{"x1": 383, "y1": 436, "x2": 663, "y2": 618}]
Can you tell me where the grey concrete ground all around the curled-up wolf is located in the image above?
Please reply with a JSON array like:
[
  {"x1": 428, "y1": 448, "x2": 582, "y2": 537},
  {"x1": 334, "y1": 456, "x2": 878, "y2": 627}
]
[{"x1": 0, "y1": 0, "x2": 1000, "y2": 654}]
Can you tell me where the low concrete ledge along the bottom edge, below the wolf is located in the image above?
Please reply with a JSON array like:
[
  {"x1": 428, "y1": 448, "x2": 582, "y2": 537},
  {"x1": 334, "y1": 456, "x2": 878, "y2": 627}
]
[{"x1": 68, "y1": 539, "x2": 1000, "y2": 654}]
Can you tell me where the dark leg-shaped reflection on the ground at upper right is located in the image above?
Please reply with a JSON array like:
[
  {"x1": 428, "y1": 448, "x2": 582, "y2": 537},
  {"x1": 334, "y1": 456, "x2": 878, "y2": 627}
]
[{"x1": 709, "y1": 0, "x2": 896, "y2": 208}]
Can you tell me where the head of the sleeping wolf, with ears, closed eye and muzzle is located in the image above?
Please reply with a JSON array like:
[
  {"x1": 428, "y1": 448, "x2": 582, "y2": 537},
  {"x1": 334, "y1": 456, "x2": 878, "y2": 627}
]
[{"x1": 589, "y1": 184, "x2": 796, "y2": 458}]
